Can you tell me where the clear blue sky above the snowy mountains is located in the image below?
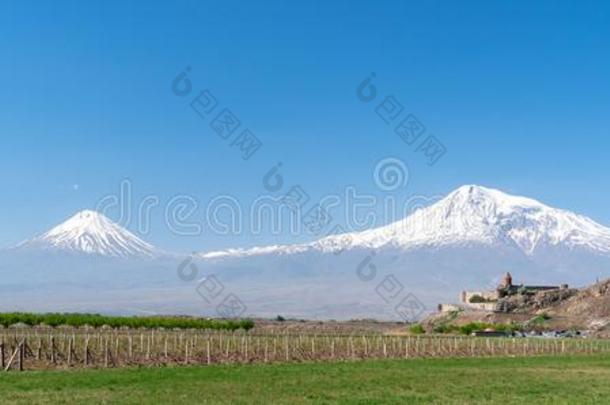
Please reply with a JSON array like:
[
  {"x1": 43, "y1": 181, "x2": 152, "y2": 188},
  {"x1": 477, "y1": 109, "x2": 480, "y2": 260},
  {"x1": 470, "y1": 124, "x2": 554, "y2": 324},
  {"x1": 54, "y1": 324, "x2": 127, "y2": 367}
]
[{"x1": 0, "y1": 1, "x2": 610, "y2": 251}]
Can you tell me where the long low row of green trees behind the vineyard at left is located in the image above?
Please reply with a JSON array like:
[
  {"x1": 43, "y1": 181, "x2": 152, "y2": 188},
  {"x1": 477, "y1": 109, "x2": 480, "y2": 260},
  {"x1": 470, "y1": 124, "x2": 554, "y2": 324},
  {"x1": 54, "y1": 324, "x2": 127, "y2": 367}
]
[{"x1": 0, "y1": 312, "x2": 254, "y2": 331}]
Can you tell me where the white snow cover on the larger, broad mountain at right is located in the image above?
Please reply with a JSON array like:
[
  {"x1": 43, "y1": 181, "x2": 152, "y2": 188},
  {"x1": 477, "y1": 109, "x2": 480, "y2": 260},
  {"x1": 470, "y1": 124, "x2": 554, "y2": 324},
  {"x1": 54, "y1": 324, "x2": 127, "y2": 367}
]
[{"x1": 199, "y1": 185, "x2": 610, "y2": 259}]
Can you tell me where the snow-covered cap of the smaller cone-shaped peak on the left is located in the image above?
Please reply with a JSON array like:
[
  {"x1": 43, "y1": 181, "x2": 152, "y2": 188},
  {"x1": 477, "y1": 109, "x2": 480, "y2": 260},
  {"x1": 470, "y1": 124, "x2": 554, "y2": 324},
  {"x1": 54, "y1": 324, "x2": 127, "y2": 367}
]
[{"x1": 17, "y1": 210, "x2": 158, "y2": 258}]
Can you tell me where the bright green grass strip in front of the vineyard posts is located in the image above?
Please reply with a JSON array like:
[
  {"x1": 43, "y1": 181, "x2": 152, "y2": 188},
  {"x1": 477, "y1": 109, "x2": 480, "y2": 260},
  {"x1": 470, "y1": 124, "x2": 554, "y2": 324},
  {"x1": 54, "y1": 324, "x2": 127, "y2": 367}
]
[{"x1": 0, "y1": 355, "x2": 610, "y2": 405}]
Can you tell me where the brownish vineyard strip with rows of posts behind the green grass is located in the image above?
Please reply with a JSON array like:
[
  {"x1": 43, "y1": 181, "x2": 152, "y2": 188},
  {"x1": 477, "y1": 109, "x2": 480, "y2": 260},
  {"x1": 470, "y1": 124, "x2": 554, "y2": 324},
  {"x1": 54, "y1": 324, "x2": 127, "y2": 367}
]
[{"x1": 0, "y1": 330, "x2": 610, "y2": 371}]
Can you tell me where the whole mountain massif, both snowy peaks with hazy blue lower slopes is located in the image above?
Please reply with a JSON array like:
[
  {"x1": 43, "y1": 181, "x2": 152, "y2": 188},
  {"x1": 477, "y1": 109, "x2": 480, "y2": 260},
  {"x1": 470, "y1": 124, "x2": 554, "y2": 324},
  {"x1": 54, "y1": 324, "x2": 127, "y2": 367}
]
[{"x1": 0, "y1": 186, "x2": 610, "y2": 320}]
